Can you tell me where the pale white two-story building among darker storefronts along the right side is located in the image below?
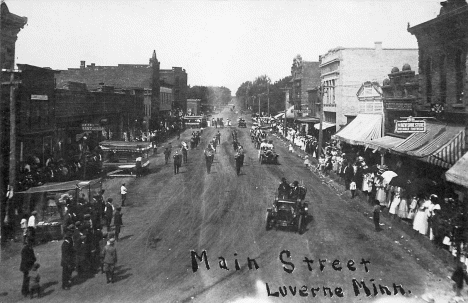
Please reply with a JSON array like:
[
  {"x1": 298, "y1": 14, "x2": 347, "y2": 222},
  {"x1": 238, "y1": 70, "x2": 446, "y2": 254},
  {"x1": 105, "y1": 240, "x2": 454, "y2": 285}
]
[{"x1": 315, "y1": 42, "x2": 418, "y2": 130}]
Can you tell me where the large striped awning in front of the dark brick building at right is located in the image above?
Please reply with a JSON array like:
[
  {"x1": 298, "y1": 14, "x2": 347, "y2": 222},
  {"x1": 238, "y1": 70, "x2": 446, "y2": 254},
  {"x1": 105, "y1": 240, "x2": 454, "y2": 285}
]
[{"x1": 391, "y1": 121, "x2": 465, "y2": 168}]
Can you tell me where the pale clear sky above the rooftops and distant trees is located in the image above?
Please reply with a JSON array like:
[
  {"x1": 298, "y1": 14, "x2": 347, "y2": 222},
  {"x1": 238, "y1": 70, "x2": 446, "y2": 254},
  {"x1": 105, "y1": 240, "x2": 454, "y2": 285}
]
[{"x1": 5, "y1": 0, "x2": 441, "y2": 95}]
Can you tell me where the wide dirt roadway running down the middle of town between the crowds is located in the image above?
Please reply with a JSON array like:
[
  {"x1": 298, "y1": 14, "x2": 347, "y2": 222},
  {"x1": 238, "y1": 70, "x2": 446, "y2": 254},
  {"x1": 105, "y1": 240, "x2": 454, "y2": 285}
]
[{"x1": 0, "y1": 102, "x2": 456, "y2": 303}]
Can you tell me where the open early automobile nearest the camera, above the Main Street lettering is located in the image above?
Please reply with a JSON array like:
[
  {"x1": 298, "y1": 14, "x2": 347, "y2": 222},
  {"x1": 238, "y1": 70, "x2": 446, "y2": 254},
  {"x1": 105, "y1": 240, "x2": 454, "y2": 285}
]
[{"x1": 266, "y1": 188, "x2": 309, "y2": 234}]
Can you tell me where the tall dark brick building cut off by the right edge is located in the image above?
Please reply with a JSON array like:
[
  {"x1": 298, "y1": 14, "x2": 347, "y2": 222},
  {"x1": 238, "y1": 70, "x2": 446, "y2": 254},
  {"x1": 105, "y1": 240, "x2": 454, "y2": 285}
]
[{"x1": 408, "y1": 0, "x2": 468, "y2": 123}]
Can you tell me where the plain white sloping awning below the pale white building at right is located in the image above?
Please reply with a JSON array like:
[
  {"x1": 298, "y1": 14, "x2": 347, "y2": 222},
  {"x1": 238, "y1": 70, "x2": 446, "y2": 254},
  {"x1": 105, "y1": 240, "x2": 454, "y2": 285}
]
[{"x1": 334, "y1": 114, "x2": 382, "y2": 145}]
